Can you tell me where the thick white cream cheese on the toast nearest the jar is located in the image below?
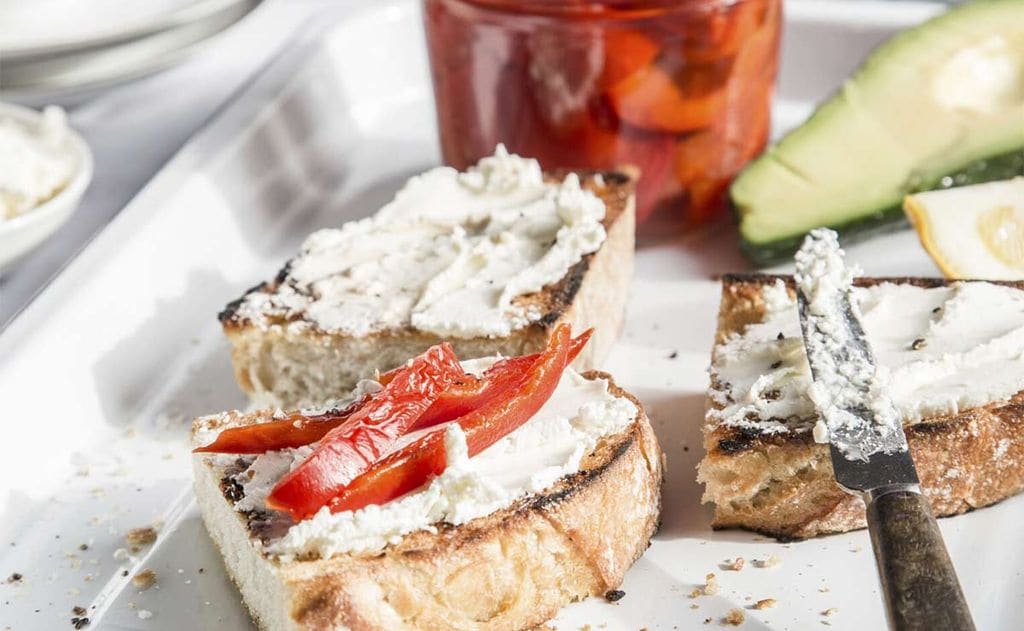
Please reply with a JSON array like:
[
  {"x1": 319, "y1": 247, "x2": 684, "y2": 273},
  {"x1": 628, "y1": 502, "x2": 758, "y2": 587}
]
[{"x1": 238, "y1": 145, "x2": 605, "y2": 337}]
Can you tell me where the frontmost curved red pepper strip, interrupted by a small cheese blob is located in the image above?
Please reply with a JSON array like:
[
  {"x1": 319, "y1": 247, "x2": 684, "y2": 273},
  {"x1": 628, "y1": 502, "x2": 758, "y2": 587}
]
[{"x1": 329, "y1": 325, "x2": 570, "y2": 512}]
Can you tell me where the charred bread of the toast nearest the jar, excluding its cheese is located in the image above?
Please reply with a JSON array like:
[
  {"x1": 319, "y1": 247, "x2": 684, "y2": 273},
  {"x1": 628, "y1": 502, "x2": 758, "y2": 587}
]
[{"x1": 219, "y1": 172, "x2": 636, "y2": 408}]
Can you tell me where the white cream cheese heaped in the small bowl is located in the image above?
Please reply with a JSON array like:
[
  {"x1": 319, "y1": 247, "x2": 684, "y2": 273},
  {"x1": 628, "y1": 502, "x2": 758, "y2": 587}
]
[{"x1": 0, "y1": 106, "x2": 78, "y2": 221}]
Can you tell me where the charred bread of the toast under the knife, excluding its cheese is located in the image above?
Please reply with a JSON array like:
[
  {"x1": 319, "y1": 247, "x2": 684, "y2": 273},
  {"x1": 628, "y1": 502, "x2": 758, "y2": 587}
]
[{"x1": 698, "y1": 276, "x2": 1024, "y2": 539}]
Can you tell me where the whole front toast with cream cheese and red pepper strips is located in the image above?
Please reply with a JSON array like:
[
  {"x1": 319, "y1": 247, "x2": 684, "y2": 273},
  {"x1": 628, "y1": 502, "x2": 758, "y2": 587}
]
[{"x1": 193, "y1": 324, "x2": 664, "y2": 631}]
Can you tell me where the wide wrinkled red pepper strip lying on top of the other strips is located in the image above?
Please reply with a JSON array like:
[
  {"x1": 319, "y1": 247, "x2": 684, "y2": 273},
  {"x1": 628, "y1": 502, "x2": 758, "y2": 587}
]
[{"x1": 266, "y1": 344, "x2": 465, "y2": 519}]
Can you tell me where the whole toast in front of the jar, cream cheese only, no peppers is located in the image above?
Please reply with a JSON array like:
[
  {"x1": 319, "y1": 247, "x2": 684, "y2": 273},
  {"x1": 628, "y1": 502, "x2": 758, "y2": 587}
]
[{"x1": 220, "y1": 146, "x2": 636, "y2": 408}]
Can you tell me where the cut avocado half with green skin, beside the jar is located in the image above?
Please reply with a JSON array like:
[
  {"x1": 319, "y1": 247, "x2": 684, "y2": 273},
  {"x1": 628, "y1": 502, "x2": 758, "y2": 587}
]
[{"x1": 730, "y1": 0, "x2": 1024, "y2": 263}]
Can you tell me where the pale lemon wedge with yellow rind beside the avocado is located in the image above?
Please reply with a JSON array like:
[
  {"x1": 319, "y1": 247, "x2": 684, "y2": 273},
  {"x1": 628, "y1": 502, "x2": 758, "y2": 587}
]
[{"x1": 903, "y1": 177, "x2": 1024, "y2": 281}]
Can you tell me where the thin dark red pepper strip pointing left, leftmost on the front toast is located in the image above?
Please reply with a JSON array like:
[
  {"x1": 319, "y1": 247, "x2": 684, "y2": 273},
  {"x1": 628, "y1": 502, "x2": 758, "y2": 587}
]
[{"x1": 193, "y1": 396, "x2": 370, "y2": 454}]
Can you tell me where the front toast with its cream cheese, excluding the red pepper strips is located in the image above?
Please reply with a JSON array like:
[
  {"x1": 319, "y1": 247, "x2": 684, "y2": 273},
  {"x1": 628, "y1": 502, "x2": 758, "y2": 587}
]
[{"x1": 193, "y1": 366, "x2": 664, "y2": 631}]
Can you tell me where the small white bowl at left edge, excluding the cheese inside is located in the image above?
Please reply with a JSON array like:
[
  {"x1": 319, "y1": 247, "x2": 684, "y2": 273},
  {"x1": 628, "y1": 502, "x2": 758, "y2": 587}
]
[{"x1": 0, "y1": 103, "x2": 92, "y2": 269}]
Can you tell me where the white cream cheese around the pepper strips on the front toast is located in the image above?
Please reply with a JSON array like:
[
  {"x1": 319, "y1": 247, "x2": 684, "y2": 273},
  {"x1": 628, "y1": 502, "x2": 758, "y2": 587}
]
[{"x1": 211, "y1": 360, "x2": 637, "y2": 558}]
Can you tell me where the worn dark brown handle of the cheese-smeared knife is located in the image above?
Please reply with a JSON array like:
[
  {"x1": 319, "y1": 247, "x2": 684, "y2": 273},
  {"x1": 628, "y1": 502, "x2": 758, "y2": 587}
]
[{"x1": 867, "y1": 489, "x2": 975, "y2": 631}]
